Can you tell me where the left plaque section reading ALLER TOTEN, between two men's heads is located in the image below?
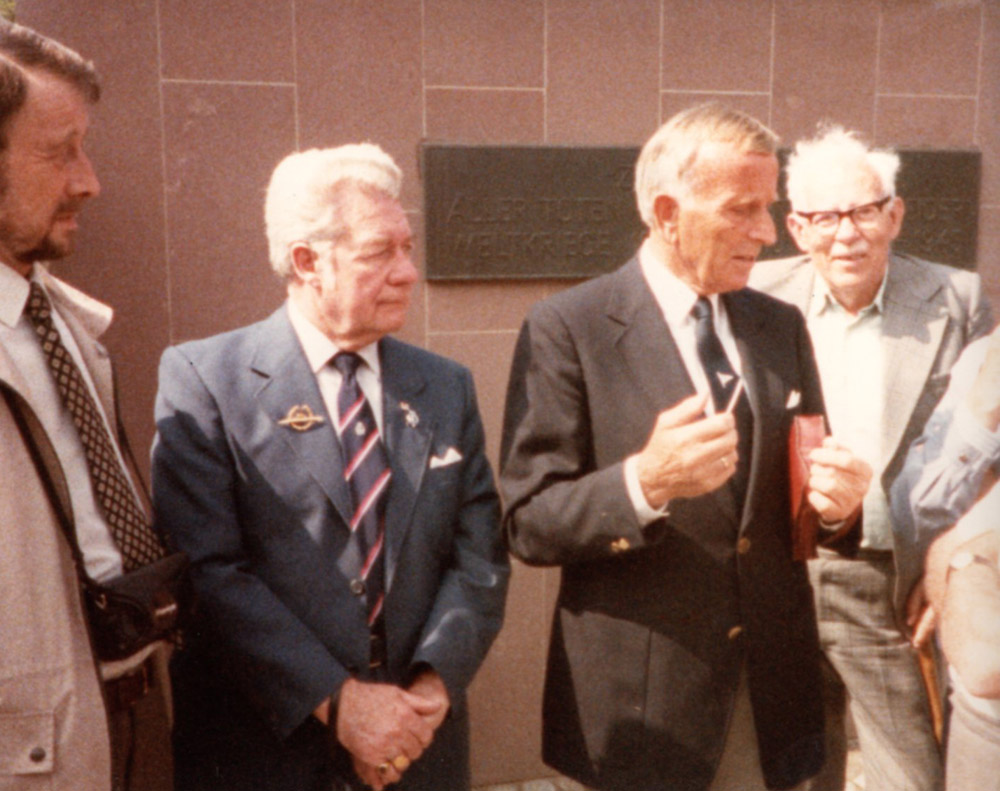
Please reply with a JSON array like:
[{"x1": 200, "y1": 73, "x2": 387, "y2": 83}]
[{"x1": 421, "y1": 144, "x2": 644, "y2": 280}]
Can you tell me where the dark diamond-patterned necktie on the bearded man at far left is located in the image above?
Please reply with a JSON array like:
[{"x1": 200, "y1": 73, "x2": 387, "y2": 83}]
[{"x1": 26, "y1": 283, "x2": 164, "y2": 571}]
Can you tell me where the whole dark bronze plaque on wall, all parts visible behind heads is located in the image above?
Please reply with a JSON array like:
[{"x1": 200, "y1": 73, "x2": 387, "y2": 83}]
[{"x1": 420, "y1": 143, "x2": 981, "y2": 280}]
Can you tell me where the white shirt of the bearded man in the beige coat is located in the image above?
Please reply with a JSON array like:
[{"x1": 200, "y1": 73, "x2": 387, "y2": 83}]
[{"x1": 0, "y1": 264, "x2": 124, "y2": 581}]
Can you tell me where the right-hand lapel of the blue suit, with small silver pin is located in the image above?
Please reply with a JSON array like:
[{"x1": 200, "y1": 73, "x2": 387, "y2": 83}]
[{"x1": 379, "y1": 338, "x2": 432, "y2": 592}]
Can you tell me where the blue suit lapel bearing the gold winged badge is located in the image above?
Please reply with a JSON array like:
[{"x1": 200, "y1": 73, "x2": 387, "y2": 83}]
[{"x1": 250, "y1": 305, "x2": 353, "y2": 526}]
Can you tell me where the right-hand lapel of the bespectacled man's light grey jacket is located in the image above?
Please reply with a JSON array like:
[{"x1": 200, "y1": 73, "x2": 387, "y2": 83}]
[{"x1": 876, "y1": 255, "x2": 948, "y2": 475}]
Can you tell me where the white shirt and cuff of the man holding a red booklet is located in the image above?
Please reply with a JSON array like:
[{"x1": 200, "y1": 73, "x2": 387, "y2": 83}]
[{"x1": 624, "y1": 239, "x2": 743, "y2": 525}]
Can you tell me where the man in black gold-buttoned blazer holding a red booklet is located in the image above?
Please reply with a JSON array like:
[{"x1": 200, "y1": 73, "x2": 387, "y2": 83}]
[{"x1": 501, "y1": 105, "x2": 870, "y2": 791}]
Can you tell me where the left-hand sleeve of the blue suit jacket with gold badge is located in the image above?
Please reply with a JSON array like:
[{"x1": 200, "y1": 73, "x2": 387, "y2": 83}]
[{"x1": 152, "y1": 348, "x2": 349, "y2": 737}]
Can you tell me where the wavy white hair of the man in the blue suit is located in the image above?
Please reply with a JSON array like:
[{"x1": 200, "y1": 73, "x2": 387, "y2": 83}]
[{"x1": 264, "y1": 143, "x2": 403, "y2": 280}]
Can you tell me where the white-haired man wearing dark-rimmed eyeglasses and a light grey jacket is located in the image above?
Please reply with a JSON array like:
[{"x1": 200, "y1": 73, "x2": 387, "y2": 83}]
[{"x1": 750, "y1": 127, "x2": 992, "y2": 791}]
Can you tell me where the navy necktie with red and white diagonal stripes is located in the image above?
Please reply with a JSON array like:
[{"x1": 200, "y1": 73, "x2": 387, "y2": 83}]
[{"x1": 333, "y1": 352, "x2": 392, "y2": 626}]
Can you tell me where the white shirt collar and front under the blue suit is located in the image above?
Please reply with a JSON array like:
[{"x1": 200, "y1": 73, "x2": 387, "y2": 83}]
[{"x1": 287, "y1": 299, "x2": 384, "y2": 437}]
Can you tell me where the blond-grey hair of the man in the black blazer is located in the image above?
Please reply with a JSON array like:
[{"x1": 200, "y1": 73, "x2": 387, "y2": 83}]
[{"x1": 635, "y1": 102, "x2": 778, "y2": 228}]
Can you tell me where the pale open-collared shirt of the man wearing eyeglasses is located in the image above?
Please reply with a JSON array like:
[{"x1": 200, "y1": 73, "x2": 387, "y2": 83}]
[{"x1": 806, "y1": 277, "x2": 893, "y2": 549}]
